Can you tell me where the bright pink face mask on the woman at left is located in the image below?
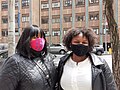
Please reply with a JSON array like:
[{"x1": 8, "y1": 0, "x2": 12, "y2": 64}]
[{"x1": 30, "y1": 38, "x2": 45, "y2": 51}]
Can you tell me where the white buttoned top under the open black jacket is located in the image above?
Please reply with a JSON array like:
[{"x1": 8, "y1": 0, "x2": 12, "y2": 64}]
[{"x1": 60, "y1": 58, "x2": 92, "y2": 90}]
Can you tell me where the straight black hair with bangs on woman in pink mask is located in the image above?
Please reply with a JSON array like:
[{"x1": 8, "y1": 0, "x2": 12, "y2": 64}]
[{"x1": 16, "y1": 25, "x2": 47, "y2": 58}]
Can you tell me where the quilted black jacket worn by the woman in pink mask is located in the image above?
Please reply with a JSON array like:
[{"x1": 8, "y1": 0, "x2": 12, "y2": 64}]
[{"x1": 0, "y1": 54, "x2": 56, "y2": 90}]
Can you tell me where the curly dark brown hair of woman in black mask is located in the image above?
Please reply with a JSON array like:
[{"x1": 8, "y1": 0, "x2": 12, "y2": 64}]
[{"x1": 63, "y1": 28, "x2": 97, "y2": 51}]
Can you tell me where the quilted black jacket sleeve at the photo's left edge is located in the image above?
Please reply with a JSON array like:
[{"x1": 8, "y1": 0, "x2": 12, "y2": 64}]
[{"x1": 0, "y1": 57, "x2": 19, "y2": 90}]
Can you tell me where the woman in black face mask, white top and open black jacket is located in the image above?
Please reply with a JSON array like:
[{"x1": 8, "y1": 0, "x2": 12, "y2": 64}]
[{"x1": 58, "y1": 29, "x2": 117, "y2": 90}]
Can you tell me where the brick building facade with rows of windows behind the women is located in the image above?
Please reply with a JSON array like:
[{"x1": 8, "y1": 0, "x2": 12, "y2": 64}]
[{"x1": 0, "y1": 0, "x2": 120, "y2": 49}]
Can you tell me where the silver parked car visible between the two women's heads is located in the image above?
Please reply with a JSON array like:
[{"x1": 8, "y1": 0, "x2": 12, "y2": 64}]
[{"x1": 47, "y1": 44, "x2": 67, "y2": 54}]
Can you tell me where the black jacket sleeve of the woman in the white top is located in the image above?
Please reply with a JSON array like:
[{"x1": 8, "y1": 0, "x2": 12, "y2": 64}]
[{"x1": 103, "y1": 61, "x2": 118, "y2": 90}]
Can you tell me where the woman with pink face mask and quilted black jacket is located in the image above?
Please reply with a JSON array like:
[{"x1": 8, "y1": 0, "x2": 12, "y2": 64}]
[{"x1": 0, "y1": 25, "x2": 56, "y2": 90}]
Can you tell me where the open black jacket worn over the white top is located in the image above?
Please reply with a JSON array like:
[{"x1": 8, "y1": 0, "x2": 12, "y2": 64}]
[{"x1": 57, "y1": 53, "x2": 117, "y2": 90}]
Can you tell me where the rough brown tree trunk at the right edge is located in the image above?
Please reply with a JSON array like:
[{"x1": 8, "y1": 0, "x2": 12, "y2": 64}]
[{"x1": 105, "y1": 0, "x2": 120, "y2": 90}]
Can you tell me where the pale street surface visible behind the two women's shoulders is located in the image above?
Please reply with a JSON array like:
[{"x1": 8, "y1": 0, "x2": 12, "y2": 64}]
[{"x1": 54, "y1": 54, "x2": 112, "y2": 71}]
